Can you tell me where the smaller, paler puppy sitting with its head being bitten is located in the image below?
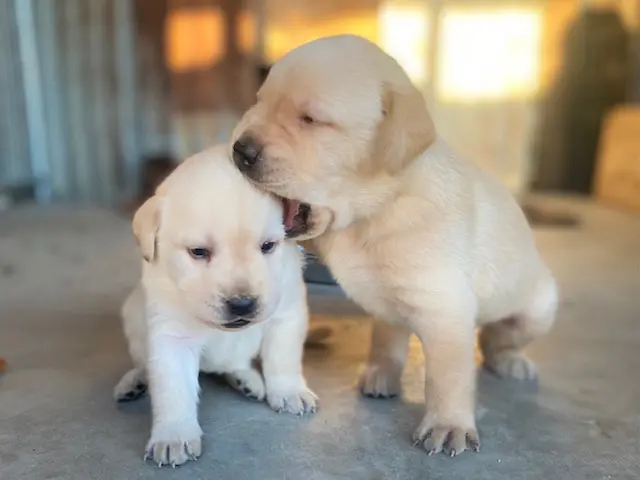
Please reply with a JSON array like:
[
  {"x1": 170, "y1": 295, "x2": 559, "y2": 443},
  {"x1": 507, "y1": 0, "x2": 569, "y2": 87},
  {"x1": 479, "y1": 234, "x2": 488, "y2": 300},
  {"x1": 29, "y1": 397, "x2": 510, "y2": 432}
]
[{"x1": 115, "y1": 146, "x2": 316, "y2": 465}]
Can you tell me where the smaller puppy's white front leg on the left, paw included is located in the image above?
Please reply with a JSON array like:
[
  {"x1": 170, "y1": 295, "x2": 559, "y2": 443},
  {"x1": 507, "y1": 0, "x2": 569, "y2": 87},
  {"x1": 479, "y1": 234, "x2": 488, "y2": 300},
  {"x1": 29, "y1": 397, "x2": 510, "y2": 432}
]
[{"x1": 145, "y1": 333, "x2": 202, "y2": 466}]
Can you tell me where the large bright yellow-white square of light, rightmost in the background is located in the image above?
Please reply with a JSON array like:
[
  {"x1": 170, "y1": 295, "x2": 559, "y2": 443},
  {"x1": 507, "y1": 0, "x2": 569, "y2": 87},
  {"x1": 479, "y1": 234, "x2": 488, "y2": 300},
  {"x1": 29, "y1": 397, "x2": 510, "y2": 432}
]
[{"x1": 437, "y1": 9, "x2": 542, "y2": 101}]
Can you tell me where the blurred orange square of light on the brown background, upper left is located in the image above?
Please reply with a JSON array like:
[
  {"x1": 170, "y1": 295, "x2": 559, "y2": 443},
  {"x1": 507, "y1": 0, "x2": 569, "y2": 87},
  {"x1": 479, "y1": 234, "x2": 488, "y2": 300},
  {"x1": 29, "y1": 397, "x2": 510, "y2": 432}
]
[{"x1": 165, "y1": 7, "x2": 225, "y2": 72}]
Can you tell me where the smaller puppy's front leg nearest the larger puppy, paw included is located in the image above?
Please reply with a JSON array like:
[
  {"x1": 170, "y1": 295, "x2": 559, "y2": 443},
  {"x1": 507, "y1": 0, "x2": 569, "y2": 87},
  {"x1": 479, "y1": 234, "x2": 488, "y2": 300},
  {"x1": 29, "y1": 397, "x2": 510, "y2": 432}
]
[{"x1": 261, "y1": 306, "x2": 317, "y2": 415}]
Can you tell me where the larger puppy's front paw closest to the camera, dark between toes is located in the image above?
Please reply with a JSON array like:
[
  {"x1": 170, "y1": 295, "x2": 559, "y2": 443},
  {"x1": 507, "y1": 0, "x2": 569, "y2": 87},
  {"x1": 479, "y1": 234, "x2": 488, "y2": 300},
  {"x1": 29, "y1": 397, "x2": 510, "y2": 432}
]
[{"x1": 413, "y1": 414, "x2": 480, "y2": 457}]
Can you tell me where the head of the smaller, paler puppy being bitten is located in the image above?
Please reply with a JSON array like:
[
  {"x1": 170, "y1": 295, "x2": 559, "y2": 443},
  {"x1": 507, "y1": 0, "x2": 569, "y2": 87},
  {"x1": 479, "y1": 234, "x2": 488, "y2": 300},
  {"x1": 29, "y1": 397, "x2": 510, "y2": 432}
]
[{"x1": 133, "y1": 147, "x2": 292, "y2": 330}]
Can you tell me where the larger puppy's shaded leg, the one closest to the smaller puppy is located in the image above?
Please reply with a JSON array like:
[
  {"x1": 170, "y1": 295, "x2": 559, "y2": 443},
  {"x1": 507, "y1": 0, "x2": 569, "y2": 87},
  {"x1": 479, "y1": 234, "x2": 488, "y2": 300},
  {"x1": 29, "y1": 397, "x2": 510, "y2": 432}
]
[{"x1": 359, "y1": 322, "x2": 411, "y2": 398}]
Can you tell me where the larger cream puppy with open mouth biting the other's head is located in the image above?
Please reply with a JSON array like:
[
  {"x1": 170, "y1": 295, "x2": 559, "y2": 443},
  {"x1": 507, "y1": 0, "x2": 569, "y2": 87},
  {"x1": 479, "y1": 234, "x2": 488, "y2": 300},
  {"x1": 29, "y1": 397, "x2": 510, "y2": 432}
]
[{"x1": 233, "y1": 35, "x2": 557, "y2": 456}]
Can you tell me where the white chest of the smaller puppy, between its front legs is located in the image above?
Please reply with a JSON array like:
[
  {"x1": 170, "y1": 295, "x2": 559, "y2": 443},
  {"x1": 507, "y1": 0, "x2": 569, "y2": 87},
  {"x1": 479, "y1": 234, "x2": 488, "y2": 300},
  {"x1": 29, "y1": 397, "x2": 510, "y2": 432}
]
[{"x1": 200, "y1": 324, "x2": 264, "y2": 373}]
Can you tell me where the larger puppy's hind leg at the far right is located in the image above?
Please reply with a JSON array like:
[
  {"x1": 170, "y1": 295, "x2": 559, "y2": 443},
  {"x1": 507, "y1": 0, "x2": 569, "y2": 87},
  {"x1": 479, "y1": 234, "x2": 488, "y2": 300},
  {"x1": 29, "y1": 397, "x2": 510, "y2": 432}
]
[{"x1": 480, "y1": 277, "x2": 558, "y2": 380}]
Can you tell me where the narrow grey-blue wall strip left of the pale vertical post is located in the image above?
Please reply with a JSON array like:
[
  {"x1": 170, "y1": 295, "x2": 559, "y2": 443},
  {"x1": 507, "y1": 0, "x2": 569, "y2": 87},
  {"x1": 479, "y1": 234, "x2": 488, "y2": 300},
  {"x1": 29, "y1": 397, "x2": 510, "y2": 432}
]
[{"x1": 0, "y1": 0, "x2": 32, "y2": 195}]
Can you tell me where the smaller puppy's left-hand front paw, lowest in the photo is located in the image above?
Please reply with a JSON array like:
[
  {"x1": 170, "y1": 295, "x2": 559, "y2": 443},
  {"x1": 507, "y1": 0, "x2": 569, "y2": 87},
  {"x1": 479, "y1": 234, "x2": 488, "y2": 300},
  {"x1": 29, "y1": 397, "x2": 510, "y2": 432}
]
[{"x1": 144, "y1": 424, "x2": 202, "y2": 467}]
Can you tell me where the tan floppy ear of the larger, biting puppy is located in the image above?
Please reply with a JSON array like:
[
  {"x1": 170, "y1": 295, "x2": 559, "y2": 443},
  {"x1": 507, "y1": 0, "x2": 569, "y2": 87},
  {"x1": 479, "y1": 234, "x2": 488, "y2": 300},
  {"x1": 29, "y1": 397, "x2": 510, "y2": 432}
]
[{"x1": 375, "y1": 82, "x2": 436, "y2": 174}]
